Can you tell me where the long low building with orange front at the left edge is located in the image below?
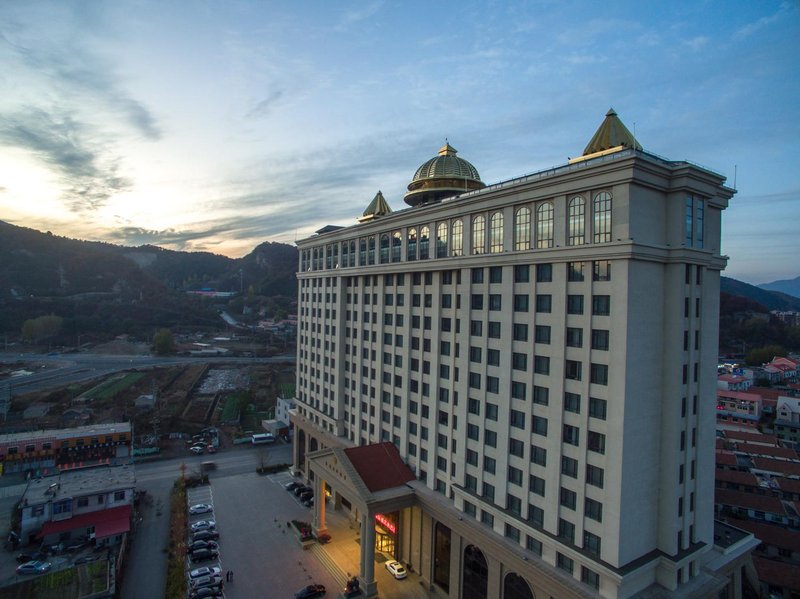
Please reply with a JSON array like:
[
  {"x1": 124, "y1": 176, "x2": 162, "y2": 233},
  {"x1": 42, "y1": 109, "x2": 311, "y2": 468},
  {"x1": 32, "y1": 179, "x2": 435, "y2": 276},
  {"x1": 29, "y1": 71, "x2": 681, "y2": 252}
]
[{"x1": 0, "y1": 422, "x2": 132, "y2": 476}]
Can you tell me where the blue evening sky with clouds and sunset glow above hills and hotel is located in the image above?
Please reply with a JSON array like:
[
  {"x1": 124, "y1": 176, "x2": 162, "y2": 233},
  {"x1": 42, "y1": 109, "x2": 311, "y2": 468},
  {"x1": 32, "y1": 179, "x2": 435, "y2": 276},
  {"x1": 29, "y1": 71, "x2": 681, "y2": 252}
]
[{"x1": 0, "y1": 0, "x2": 800, "y2": 283}]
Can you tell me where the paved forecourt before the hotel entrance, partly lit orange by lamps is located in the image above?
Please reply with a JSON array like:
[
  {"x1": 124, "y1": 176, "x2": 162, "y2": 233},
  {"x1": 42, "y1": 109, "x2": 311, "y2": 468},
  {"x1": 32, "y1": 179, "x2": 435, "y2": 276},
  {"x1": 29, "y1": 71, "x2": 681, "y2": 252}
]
[{"x1": 187, "y1": 472, "x2": 433, "y2": 599}]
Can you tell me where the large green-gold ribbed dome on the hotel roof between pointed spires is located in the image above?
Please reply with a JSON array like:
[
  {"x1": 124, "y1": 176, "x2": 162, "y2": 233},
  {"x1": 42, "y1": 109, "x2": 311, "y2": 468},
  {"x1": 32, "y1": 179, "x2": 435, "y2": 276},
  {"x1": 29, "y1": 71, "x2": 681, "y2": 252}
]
[{"x1": 403, "y1": 143, "x2": 485, "y2": 206}]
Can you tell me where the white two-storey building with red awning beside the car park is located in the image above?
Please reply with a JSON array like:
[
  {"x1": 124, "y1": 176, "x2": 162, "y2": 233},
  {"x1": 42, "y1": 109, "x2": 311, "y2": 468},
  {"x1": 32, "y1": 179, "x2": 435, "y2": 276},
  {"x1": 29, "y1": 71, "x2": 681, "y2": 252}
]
[{"x1": 19, "y1": 465, "x2": 136, "y2": 545}]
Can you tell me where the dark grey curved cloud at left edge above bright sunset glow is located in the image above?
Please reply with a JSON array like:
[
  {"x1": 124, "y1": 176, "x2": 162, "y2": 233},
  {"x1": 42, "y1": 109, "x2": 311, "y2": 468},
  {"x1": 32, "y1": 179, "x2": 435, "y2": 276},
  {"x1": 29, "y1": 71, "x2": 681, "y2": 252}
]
[{"x1": 0, "y1": 108, "x2": 132, "y2": 212}]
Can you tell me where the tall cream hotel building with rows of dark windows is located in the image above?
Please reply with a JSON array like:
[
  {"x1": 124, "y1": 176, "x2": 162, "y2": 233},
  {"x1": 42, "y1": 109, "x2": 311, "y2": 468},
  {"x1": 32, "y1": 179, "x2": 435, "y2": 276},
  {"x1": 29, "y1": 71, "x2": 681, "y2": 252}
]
[{"x1": 293, "y1": 111, "x2": 752, "y2": 598}]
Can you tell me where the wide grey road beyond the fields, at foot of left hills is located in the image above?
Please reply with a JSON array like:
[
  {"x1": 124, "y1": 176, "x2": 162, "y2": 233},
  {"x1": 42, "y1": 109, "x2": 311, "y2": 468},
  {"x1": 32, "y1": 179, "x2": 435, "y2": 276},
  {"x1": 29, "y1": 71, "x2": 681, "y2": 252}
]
[{"x1": 0, "y1": 353, "x2": 295, "y2": 397}]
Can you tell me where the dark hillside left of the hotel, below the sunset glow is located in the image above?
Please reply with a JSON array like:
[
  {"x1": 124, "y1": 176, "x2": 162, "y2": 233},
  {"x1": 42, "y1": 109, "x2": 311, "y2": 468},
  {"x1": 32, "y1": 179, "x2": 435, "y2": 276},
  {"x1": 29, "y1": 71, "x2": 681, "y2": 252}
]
[{"x1": 0, "y1": 221, "x2": 297, "y2": 343}]
